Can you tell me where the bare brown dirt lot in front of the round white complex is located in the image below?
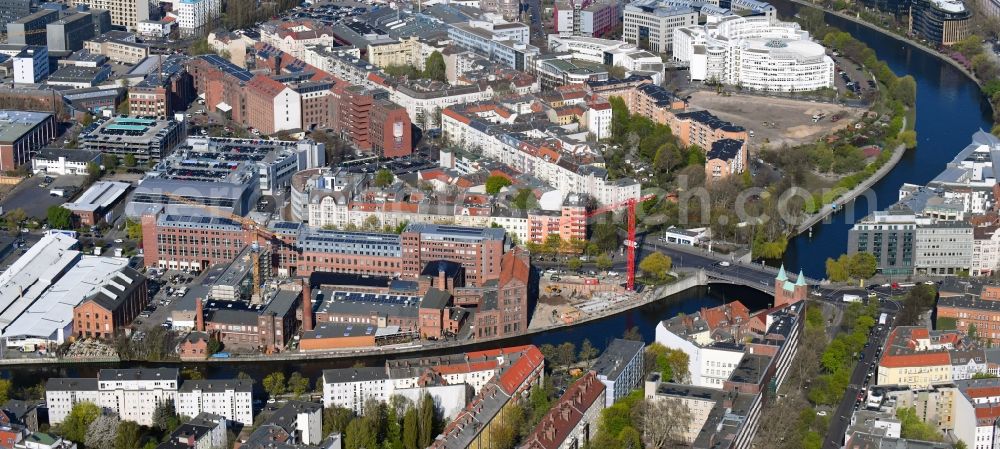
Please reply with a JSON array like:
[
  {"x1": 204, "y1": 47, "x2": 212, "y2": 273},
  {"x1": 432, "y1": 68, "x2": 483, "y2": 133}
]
[{"x1": 690, "y1": 91, "x2": 864, "y2": 150}]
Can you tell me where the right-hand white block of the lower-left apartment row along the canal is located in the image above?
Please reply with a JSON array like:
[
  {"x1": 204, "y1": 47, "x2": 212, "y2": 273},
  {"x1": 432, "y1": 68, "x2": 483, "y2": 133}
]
[{"x1": 175, "y1": 379, "x2": 253, "y2": 426}]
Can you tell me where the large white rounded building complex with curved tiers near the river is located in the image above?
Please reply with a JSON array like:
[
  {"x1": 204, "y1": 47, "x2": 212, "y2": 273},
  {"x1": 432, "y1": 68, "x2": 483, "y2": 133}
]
[{"x1": 673, "y1": 15, "x2": 834, "y2": 92}]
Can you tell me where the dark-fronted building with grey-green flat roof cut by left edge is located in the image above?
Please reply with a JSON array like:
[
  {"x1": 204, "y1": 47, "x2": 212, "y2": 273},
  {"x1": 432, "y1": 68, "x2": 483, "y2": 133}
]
[{"x1": 0, "y1": 110, "x2": 56, "y2": 171}]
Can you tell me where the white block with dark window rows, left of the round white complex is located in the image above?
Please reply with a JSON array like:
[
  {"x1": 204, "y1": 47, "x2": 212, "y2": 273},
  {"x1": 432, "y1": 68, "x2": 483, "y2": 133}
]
[{"x1": 623, "y1": 0, "x2": 698, "y2": 53}]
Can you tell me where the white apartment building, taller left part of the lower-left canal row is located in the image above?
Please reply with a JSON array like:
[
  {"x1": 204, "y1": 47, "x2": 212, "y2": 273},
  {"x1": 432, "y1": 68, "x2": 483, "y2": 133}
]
[{"x1": 45, "y1": 368, "x2": 178, "y2": 426}]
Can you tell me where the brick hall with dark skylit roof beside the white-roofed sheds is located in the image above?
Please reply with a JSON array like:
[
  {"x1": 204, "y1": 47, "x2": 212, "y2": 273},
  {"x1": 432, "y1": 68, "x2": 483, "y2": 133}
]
[{"x1": 73, "y1": 267, "x2": 149, "y2": 338}]
